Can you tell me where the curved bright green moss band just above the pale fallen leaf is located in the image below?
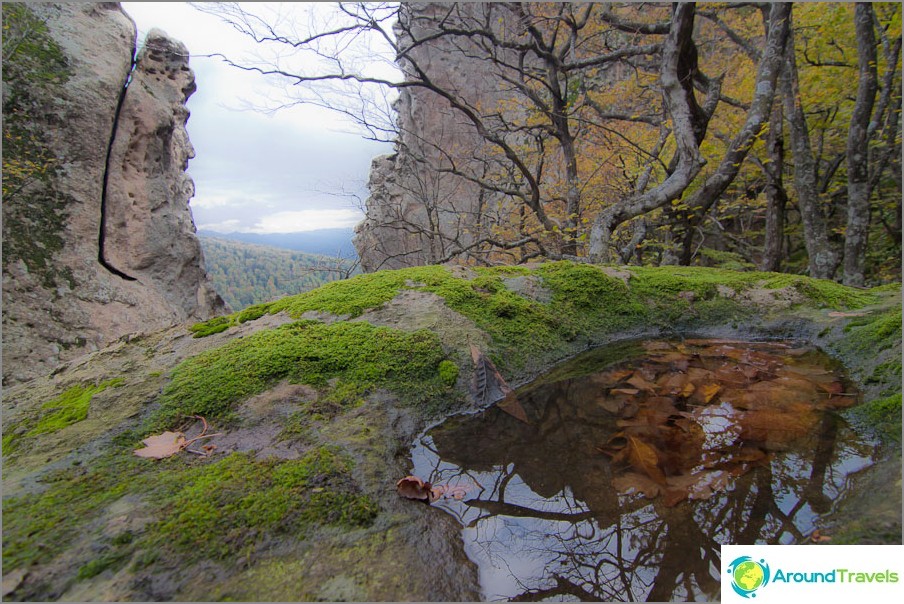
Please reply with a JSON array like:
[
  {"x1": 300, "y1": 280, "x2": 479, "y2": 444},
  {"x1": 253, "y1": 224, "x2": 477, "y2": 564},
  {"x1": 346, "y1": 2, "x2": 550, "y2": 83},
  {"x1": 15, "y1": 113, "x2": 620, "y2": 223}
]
[{"x1": 151, "y1": 321, "x2": 456, "y2": 429}]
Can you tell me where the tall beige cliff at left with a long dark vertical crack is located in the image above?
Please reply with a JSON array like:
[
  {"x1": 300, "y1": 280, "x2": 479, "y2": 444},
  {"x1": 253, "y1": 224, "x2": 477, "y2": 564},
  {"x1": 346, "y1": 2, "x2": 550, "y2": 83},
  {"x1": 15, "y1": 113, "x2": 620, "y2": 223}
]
[{"x1": 3, "y1": 3, "x2": 225, "y2": 384}]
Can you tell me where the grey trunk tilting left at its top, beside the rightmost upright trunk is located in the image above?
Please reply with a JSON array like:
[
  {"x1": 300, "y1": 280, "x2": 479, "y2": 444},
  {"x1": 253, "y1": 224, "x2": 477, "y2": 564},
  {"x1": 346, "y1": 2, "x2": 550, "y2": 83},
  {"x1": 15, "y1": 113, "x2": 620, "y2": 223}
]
[{"x1": 781, "y1": 19, "x2": 838, "y2": 279}]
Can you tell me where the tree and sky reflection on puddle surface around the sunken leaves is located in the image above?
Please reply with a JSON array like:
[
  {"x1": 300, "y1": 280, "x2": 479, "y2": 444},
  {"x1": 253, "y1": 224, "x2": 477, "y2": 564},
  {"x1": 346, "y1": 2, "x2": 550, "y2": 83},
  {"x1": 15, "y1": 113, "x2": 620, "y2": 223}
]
[{"x1": 412, "y1": 341, "x2": 873, "y2": 601}]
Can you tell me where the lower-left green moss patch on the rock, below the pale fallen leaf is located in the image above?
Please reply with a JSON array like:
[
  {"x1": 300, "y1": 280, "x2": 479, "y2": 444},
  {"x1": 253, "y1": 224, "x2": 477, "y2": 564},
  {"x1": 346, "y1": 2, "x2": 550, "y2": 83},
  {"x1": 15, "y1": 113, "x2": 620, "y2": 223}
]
[{"x1": 150, "y1": 447, "x2": 378, "y2": 558}]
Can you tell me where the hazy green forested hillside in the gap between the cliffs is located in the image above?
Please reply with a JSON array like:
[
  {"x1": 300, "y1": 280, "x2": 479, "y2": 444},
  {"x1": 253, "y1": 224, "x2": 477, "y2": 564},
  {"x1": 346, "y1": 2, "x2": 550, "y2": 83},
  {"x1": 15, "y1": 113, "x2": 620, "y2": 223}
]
[{"x1": 199, "y1": 236, "x2": 358, "y2": 311}]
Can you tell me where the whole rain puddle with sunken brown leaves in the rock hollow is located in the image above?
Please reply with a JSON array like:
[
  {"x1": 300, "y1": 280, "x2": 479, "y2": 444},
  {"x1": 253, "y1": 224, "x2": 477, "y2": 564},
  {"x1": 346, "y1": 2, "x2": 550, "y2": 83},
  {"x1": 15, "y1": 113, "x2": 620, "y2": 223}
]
[{"x1": 412, "y1": 340, "x2": 875, "y2": 601}]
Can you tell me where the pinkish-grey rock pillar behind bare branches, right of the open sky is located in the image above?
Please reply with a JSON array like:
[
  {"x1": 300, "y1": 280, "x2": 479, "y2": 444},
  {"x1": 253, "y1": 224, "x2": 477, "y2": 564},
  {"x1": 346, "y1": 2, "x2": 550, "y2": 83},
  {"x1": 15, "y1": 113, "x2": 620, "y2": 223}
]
[{"x1": 354, "y1": 2, "x2": 502, "y2": 271}]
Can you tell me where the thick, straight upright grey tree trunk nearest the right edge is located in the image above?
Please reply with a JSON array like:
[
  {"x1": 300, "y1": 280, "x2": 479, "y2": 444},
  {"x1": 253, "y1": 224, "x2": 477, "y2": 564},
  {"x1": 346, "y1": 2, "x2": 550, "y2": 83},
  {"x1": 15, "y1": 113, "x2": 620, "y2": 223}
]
[{"x1": 844, "y1": 2, "x2": 879, "y2": 287}]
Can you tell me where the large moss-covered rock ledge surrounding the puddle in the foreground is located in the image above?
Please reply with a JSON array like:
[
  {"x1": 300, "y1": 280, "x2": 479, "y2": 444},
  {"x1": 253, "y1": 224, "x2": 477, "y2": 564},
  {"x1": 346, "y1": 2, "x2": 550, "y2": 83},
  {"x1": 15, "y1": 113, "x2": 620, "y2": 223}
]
[{"x1": 3, "y1": 262, "x2": 901, "y2": 601}]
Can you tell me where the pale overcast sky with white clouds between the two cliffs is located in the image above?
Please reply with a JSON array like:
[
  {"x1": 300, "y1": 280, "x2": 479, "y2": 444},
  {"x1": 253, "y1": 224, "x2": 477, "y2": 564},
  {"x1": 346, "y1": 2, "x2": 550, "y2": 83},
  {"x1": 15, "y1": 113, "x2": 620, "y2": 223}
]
[{"x1": 122, "y1": 2, "x2": 391, "y2": 233}]
